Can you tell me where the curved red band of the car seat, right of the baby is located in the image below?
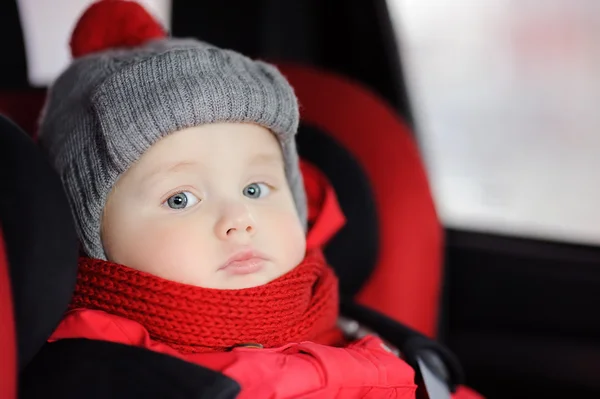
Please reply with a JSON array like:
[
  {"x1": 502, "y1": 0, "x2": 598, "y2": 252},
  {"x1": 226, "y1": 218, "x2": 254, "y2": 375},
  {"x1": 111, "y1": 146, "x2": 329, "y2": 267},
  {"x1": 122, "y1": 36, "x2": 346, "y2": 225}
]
[{"x1": 279, "y1": 65, "x2": 443, "y2": 336}]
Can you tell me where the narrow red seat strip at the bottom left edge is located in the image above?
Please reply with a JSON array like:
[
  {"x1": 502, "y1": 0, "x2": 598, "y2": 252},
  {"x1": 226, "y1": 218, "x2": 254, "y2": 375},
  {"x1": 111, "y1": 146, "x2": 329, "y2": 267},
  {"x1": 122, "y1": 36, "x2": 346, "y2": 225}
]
[{"x1": 0, "y1": 230, "x2": 17, "y2": 399}]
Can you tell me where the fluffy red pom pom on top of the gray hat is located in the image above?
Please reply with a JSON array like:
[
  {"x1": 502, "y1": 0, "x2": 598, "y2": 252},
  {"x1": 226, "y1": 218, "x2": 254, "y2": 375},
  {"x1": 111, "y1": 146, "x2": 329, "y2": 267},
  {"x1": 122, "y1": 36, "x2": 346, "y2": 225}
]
[{"x1": 70, "y1": 0, "x2": 166, "y2": 58}]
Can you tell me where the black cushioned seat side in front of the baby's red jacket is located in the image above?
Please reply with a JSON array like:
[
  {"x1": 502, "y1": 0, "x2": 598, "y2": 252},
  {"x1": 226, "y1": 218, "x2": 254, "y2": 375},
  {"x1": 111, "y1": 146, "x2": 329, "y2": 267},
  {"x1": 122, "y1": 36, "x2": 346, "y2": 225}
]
[{"x1": 19, "y1": 339, "x2": 241, "y2": 399}]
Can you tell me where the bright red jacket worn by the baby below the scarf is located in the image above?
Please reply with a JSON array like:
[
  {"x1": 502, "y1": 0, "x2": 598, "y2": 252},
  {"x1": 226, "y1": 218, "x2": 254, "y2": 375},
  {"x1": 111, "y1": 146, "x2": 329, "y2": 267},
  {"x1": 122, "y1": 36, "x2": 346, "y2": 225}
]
[{"x1": 50, "y1": 309, "x2": 416, "y2": 399}]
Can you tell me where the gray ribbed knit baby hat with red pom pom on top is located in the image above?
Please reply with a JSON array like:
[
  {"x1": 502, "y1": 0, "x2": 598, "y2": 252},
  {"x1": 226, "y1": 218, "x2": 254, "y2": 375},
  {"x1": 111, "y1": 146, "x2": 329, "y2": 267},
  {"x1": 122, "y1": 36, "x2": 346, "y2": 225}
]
[{"x1": 39, "y1": 0, "x2": 307, "y2": 259}]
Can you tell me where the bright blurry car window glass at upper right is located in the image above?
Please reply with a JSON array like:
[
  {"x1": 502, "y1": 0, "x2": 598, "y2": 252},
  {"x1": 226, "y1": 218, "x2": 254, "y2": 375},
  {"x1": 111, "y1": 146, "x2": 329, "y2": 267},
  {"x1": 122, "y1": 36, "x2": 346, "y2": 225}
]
[{"x1": 388, "y1": 0, "x2": 600, "y2": 244}]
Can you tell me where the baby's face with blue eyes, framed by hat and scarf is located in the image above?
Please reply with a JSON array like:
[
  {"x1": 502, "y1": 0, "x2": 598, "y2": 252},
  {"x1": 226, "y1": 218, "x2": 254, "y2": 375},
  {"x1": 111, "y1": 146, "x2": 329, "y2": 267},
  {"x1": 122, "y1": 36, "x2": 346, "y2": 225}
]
[{"x1": 102, "y1": 123, "x2": 306, "y2": 289}]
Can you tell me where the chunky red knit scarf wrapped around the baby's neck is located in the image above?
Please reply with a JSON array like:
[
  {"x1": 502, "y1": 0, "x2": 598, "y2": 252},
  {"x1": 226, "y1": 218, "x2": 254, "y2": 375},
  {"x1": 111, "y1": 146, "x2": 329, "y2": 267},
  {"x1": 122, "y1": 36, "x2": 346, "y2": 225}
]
[{"x1": 71, "y1": 251, "x2": 338, "y2": 353}]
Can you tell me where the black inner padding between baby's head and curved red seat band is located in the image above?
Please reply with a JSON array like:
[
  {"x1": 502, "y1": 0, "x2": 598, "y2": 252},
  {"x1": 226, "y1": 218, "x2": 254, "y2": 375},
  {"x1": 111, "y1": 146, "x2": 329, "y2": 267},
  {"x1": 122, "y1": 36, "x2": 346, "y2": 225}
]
[{"x1": 297, "y1": 123, "x2": 379, "y2": 298}]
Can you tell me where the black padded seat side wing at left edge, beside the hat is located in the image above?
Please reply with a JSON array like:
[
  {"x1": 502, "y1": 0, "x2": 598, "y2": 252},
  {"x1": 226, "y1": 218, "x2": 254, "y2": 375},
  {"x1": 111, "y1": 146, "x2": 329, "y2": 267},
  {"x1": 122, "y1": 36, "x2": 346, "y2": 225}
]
[{"x1": 0, "y1": 115, "x2": 78, "y2": 370}]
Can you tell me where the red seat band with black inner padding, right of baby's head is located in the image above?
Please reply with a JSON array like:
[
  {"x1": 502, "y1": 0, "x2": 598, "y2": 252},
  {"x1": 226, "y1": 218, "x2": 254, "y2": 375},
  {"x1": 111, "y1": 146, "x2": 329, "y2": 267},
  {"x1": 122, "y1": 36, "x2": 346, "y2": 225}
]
[{"x1": 279, "y1": 64, "x2": 443, "y2": 336}]
